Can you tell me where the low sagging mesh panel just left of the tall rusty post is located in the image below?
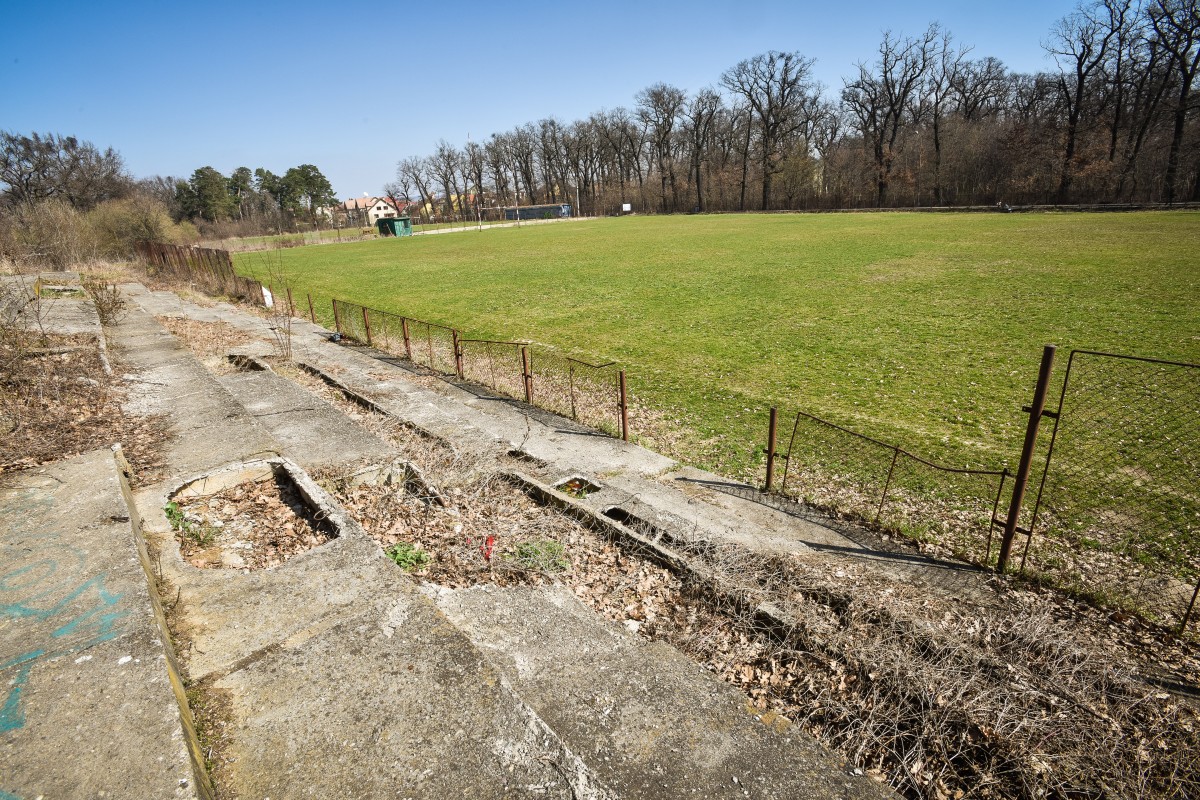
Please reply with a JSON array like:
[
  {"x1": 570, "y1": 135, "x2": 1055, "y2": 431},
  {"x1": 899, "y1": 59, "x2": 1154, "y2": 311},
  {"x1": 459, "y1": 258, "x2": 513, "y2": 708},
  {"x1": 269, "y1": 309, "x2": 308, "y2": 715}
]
[{"x1": 767, "y1": 411, "x2": 1009, "y2": 565}]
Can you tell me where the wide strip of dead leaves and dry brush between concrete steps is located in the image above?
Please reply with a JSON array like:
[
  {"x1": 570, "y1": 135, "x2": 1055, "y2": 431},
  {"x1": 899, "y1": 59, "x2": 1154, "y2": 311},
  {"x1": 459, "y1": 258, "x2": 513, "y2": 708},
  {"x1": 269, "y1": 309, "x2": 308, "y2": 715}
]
[{"x1": 324, "y1": 438, "x2": 1200, "y2": 798}]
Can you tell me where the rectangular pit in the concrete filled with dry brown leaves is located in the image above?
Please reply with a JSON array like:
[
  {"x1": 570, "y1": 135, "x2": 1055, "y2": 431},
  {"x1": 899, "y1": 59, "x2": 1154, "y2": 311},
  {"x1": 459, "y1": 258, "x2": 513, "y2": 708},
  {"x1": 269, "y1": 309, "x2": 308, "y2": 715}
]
[{"x1": 167, "y1": 476, "x2": 336, "y2": 571}]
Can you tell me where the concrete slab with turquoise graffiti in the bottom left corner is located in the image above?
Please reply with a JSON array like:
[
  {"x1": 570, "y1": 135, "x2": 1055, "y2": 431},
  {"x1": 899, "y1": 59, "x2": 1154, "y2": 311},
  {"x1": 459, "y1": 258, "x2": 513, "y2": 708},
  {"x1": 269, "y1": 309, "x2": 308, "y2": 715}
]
[{"x1": 0, "y1": 450, "x2": 209, "y2": 800}]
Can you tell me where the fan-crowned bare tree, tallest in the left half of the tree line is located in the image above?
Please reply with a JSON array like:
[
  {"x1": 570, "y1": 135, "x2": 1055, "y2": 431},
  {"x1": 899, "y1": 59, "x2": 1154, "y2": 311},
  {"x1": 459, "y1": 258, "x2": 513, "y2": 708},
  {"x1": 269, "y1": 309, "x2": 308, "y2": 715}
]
[{"x1": 721, "y1": 50, "x2": 820, "y2": 210}]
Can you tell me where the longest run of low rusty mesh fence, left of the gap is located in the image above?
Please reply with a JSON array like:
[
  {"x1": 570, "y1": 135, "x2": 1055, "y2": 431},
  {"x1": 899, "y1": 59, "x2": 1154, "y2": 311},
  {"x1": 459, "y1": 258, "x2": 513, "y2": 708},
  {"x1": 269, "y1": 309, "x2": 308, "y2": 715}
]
[{"x1": 328, "y1": 297, "x2": 629, "y2": 440}]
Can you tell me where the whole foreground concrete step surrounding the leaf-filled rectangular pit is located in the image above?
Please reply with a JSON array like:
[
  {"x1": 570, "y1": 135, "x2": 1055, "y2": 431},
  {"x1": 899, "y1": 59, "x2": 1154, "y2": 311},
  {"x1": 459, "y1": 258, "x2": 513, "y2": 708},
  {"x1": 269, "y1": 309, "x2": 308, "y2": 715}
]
[{"x1": 139, "y1": 459, "x2": 608, "y2": 799}]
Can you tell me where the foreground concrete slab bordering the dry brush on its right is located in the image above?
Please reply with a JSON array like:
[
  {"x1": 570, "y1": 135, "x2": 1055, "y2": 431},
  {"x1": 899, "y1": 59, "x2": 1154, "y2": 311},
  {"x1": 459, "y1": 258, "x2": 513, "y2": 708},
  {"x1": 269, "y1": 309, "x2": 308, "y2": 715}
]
[{"x1": 430, "y1": 585, "x2": 894, "y2": 800}]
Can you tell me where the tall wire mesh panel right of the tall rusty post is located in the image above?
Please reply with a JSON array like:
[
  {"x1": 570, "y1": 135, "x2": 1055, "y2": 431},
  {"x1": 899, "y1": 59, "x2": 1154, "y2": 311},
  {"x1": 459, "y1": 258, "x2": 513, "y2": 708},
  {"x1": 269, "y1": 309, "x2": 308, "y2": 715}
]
[{"x1": 1021, "y1": 350, "x2": 1200, "y2": 627}]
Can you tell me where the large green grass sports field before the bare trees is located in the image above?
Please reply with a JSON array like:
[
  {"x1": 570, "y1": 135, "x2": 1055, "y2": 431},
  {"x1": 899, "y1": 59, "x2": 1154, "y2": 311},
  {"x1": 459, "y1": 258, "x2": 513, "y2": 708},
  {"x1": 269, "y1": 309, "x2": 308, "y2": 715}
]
[{"x1": 235, "y1": 211, "x2": 1200, "y2": 475}]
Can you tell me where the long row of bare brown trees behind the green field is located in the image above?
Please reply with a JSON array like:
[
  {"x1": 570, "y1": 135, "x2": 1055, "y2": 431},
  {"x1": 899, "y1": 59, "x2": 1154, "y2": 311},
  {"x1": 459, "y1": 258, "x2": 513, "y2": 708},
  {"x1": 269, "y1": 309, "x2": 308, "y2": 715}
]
[{"x1": 384, "y1": 0, "x2": 1200, "y2": 216}]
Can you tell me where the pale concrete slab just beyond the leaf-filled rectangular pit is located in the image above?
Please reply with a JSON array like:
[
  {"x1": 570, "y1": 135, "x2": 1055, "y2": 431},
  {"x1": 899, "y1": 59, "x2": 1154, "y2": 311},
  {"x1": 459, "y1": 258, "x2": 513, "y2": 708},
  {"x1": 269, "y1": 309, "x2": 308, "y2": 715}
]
[{"x1": 218, "y1": 371, "x2": 395, "y2": 469}]
